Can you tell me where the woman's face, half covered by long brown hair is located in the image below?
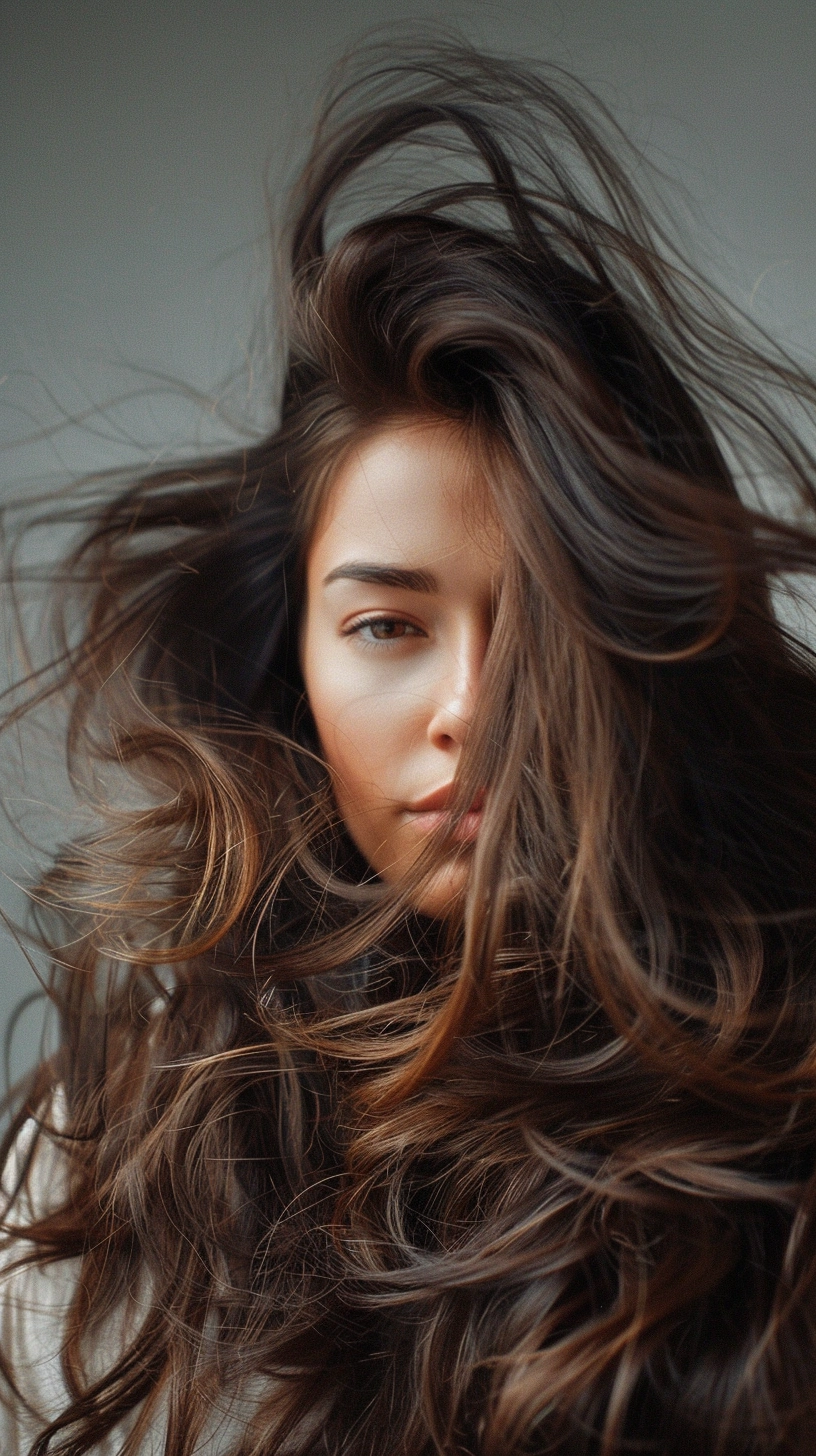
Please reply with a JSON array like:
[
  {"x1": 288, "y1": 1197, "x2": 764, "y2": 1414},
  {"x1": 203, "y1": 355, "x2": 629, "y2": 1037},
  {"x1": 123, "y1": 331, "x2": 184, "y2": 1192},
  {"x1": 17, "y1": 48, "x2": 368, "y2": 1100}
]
[{"x1": 302, "y1": 421, "x2": 501, "y2": 916}]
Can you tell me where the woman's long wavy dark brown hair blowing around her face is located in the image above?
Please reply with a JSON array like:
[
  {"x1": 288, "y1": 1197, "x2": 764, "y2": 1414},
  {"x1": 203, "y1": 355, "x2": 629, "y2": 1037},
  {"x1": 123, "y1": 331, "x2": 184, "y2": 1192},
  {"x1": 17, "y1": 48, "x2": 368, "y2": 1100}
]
[{"x1": 6, "y1": 44, "x2": 816, "y2": 1456}]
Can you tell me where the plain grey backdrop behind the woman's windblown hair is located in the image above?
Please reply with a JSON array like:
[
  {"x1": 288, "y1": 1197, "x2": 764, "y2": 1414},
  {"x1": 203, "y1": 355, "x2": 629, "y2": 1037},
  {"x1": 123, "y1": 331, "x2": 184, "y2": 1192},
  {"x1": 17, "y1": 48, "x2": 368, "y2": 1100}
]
[{"x1": 0, "y1": 0, "x2": 816, "y2": 1069}]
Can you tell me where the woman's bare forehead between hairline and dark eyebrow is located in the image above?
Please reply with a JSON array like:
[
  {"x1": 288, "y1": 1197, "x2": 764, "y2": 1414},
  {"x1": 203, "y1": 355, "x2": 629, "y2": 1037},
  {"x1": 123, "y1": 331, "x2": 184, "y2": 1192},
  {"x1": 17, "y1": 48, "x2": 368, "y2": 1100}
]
[{"x1": 309, "y1": 421, "x2": 500, "y2": 569}]
